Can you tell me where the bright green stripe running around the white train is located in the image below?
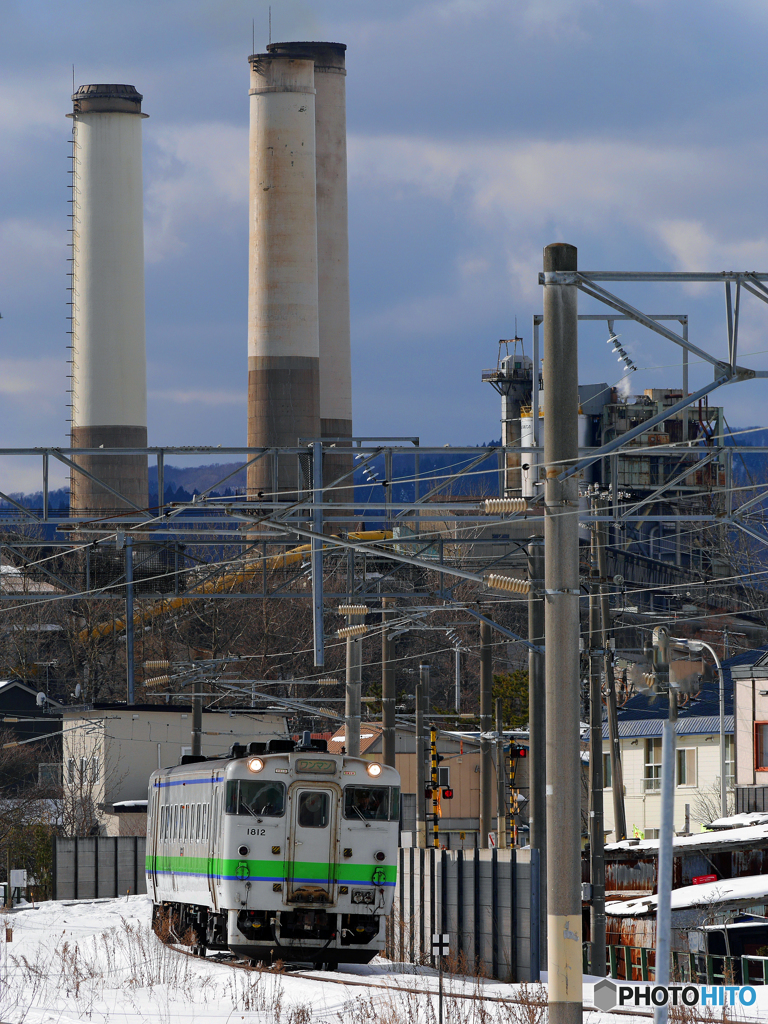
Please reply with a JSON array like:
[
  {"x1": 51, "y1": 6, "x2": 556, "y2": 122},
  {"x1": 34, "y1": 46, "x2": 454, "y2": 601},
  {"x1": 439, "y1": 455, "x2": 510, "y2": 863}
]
[{"x1": 144, "y1": 854, "x2": 397, "y2": 884}]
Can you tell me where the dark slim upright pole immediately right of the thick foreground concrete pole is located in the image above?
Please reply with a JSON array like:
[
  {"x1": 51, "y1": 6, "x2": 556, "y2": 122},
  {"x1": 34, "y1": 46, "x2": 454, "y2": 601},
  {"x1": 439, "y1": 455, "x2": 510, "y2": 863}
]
[{"x1": 589, "y1": 512, "x2": 606, "y2": 978}]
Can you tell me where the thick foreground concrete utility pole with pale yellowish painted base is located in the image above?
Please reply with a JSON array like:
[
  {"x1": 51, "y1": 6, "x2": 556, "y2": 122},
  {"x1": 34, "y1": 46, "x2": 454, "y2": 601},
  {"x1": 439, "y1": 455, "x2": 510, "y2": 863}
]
[{"x1": 544, "y1": 243, "x2": 583, "y2": 1024}]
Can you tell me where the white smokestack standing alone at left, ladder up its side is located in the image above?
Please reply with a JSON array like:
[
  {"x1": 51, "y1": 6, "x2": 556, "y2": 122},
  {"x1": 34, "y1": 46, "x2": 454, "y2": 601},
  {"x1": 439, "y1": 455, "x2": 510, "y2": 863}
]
[{"x1": 68, "y1": 85, "x2": 148, "y2": 512}]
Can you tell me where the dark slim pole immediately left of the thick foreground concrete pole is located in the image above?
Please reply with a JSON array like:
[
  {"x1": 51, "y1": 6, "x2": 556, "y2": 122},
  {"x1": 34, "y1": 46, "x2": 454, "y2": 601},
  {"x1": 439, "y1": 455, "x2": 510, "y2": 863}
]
[{"x1": 528, "y1": 536, "x2": 547, "y2": 966}]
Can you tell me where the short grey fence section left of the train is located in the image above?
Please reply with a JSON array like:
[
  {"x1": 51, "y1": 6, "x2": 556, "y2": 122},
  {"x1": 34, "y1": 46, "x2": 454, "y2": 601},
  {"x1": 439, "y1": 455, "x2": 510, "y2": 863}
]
[{"x1": 53, "y1": 836, "x2": 146, "y2": 899}]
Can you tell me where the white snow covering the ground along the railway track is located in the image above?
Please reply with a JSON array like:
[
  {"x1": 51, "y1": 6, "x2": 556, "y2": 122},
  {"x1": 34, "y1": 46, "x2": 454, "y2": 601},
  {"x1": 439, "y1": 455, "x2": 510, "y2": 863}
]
[{"x1": 0, "y1": 896, "x2": 768, "y2": 1024}]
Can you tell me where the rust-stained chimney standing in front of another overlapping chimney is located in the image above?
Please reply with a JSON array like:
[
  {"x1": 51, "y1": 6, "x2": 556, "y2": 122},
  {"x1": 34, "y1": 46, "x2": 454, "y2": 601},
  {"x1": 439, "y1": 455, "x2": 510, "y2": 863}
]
[{"x1": 248, "y1": 53, "x2": 321, "y2": 499}]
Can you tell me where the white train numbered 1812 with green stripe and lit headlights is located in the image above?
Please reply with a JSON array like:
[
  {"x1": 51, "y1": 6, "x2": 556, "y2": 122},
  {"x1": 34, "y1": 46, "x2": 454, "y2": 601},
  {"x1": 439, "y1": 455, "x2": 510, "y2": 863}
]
[{"x1": 146, "y1": 733, "x2": 400, "y2": 970}]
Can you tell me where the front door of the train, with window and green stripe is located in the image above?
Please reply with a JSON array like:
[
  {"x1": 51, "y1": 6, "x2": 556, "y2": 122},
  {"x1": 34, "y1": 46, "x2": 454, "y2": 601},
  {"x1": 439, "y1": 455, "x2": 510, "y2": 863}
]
[{"x1": 286, "y1": 782, "x2": 338, "y2": 904}]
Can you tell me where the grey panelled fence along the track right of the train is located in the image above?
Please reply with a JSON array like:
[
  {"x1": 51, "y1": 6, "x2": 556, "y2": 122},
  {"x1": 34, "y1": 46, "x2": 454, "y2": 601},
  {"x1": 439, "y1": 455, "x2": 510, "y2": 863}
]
[{"x1": 387, "y1": 848, "x2": 540, "y2": 981}]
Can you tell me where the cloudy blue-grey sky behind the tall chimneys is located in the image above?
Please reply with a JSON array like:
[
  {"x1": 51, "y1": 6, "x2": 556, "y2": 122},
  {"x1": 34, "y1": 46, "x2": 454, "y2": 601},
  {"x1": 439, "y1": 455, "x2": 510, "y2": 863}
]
[{"x1": 0, "y1": 0, "x2": 768, "y2": 490}]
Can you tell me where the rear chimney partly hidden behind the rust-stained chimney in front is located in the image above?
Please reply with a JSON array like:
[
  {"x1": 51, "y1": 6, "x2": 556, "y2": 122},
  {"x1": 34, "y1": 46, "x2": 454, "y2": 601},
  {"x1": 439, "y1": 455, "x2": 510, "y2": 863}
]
[{"x1": 267, "y1": 42, "x2": 352, "y2": 500}]
